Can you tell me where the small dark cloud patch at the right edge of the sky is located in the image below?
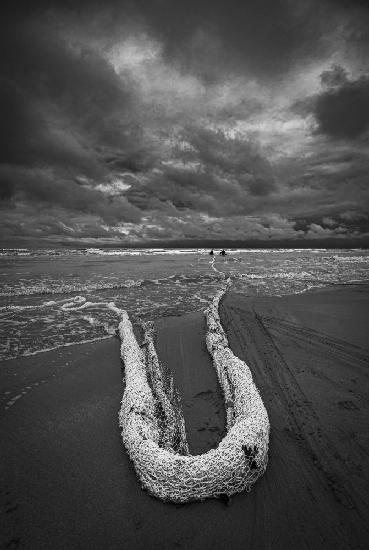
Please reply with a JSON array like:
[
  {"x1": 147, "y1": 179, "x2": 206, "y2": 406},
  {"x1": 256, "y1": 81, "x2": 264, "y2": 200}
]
[{"x1": 314, "y1": 67, "x2": 369, "y2": 139}]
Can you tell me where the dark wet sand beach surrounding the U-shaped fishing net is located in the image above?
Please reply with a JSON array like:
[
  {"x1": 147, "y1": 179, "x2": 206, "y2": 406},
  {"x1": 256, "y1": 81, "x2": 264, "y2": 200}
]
[{"x1": 0, "y1": 285, "x2": 369, "y2": 550}]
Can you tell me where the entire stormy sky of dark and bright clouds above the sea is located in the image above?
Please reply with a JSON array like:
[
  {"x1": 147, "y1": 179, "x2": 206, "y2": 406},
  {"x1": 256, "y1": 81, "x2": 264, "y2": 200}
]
[{"x1": 0, "y1": 0, "x2": 369, "y2": 246}]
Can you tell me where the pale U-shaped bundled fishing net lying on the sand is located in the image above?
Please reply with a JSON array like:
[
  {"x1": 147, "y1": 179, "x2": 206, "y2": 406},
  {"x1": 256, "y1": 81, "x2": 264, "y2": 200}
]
[{"x1": 119, "y1": 287, "x2": 269, "y2": 503}]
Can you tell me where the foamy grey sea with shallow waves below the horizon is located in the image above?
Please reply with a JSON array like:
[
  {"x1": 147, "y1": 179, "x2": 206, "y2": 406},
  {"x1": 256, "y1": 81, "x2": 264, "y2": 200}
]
[{"x1": 0, "y1": 248, "x2": 369, "y2": 361}]
